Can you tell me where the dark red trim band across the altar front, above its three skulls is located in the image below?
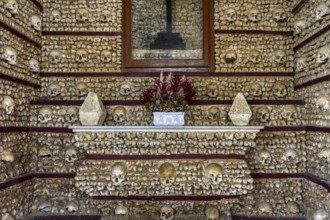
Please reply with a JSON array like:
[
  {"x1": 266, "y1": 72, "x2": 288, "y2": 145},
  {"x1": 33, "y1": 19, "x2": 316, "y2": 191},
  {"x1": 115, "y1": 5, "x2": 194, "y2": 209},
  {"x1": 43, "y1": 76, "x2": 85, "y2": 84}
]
[{"x1": 86, "y1": 154, "x2": 245, "y2": 160}]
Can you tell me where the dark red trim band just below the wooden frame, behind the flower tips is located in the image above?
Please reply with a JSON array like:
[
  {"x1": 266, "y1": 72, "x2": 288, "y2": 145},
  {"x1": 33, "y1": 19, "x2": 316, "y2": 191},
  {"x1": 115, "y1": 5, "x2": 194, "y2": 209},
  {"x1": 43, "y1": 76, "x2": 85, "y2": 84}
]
[{"x1": 40, "y1": 72, "x2": 294, "y2": 77}]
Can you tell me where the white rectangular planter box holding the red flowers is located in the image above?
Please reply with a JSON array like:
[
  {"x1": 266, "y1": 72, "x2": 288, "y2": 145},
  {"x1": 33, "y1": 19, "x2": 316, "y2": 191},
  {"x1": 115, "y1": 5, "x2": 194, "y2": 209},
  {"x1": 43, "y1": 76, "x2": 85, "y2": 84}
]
[{"x1": 154, "y1": 112, "x2": 185, "y2": 126}]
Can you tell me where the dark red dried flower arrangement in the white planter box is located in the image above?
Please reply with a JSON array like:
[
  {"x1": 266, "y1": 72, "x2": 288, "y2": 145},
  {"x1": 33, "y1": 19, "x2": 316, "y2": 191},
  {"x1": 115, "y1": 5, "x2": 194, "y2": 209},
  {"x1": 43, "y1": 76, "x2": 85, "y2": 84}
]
[{"x1": 143, "y1": 73, "x2": 196, "y2": 112}]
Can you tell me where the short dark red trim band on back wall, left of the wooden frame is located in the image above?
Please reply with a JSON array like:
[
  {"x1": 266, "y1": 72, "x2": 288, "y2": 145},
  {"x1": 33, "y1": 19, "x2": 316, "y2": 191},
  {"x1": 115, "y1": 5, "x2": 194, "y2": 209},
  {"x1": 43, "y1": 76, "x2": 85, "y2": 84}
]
[{"x1": 42, "y1": 31, "x2": 122, "y2": 36}]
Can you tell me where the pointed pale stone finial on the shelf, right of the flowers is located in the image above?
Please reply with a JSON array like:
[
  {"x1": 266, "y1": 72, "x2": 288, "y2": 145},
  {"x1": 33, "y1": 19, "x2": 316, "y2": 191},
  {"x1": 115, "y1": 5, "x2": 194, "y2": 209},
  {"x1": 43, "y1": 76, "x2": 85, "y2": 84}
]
[{"x1": 228, "y1": 93, "x2": 252, "y2": 126}]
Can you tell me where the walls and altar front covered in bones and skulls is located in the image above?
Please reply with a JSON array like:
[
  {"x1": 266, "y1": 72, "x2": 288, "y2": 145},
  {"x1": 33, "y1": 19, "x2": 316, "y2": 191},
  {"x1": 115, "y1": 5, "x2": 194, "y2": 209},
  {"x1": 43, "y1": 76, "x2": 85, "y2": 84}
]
[{"x1": 0, "y1": 0, "x2": 330, "y2": 219}]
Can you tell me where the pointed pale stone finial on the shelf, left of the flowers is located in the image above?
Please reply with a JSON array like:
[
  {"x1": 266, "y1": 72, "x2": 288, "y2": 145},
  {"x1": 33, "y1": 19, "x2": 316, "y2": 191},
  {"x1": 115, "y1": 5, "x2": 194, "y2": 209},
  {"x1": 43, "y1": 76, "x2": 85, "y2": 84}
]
[{"x1": 79, "y1": 92, "x2": 107, "y2": 126}]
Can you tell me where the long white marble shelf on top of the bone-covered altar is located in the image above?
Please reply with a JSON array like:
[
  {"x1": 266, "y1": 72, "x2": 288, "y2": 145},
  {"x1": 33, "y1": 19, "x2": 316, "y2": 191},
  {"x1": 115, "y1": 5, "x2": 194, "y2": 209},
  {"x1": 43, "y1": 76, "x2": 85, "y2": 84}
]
[{"x1": 69, "y1": 126, "x2": 264, "y2": 133}]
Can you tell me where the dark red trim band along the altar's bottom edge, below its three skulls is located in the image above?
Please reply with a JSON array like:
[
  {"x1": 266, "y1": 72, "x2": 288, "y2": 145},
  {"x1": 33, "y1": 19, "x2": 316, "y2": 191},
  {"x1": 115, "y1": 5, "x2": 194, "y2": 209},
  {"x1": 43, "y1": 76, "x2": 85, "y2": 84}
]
[{"x1": 92, "y1": 195, "x2": 241, "y2": 201}]
